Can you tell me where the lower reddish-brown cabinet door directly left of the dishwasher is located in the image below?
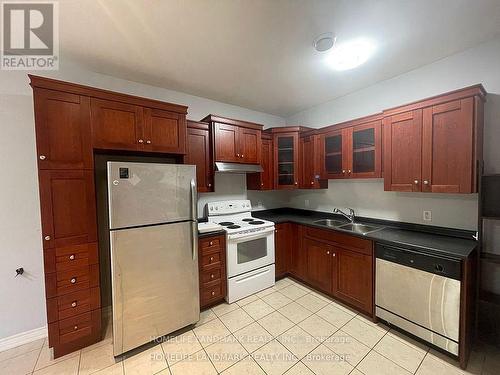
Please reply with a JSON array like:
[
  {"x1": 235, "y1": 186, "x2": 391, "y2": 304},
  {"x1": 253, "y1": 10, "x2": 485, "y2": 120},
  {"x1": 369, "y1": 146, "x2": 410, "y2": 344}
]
[{"x1": 333, "y1": 247, "x2": 373, "y2": 314}]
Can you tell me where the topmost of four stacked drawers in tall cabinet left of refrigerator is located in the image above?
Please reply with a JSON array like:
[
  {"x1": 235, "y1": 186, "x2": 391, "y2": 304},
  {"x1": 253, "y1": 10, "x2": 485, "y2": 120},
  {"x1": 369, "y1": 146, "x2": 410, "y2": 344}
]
[{"x1": 44, "y1": 242, "x2": 99, "y2": 273}]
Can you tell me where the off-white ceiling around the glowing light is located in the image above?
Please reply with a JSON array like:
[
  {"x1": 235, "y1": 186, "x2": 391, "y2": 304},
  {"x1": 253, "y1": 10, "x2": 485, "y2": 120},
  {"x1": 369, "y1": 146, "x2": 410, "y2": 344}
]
[{"x1": 59, "y1": 0, "x2": 500, "y2": 117}]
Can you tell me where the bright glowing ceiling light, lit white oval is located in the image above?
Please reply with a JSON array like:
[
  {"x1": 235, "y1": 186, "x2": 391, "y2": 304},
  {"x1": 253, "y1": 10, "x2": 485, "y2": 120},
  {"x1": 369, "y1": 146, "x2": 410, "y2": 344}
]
[{"x1": 326, "y1": 38, "x2": 375, "y2": 70}]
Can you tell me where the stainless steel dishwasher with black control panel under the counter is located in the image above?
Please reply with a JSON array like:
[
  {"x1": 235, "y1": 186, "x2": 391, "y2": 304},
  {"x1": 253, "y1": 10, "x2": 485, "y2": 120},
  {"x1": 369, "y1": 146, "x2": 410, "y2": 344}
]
[{"x1": 375, "y1": 244, "x2": 461, "y2": 355}]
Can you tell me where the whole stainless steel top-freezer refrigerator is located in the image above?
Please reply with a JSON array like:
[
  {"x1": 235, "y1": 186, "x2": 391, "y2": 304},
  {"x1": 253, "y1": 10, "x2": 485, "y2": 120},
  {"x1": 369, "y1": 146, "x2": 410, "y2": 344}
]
[{"x1": 107, "y1": 162, "x2": 200, "y2": 356}]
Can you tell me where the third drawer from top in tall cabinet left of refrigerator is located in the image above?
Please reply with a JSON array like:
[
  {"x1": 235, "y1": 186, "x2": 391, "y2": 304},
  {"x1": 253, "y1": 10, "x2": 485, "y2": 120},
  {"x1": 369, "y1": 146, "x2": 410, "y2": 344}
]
[{"x1": 47, "y1": 287, "x2": 101, "y2": 323}]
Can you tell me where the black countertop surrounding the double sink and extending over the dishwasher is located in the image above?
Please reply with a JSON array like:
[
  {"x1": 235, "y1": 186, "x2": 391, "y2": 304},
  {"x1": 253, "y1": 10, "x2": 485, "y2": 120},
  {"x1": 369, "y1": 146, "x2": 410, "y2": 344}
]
[{"x1": 252, "y1": 208, "x2": 478, "y2": 259}]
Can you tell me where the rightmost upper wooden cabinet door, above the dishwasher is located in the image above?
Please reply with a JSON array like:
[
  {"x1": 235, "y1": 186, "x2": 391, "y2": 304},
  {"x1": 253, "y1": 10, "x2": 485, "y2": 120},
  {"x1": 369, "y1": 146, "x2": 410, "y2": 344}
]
[{"x1": 422, "y1": 98, "x2": 474, "y2": 193}]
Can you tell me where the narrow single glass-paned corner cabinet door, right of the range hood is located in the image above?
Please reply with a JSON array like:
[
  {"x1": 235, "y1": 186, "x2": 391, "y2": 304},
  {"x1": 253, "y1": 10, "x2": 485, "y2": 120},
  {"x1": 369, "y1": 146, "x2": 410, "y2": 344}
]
[{"x1": 274, "y1": 133, "x2": 299, "y2": 189}]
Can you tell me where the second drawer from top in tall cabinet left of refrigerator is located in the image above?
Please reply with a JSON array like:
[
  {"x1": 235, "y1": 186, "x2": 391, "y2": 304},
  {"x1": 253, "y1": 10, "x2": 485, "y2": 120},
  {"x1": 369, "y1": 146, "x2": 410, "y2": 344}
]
[{"x1": 45, "y1": 264, "x2": 99, "y2": 298}]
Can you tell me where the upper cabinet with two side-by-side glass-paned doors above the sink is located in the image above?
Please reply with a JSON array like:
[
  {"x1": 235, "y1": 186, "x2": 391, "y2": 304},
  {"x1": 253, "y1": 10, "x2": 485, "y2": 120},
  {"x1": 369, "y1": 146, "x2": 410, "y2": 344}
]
[{"x1": 320, "y1": 116, "x2": 382, "y2": 179}]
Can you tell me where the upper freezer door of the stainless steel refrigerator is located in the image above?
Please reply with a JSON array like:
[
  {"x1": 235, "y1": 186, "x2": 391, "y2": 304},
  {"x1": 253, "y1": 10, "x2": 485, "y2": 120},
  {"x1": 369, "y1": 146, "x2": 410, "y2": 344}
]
[{"x1": 108, "y1": 162, "x2": 197, "y2": 229}]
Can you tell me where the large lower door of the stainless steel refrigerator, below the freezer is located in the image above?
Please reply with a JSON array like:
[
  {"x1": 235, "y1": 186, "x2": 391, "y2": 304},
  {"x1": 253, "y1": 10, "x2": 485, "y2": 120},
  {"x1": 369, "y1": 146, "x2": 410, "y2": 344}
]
[{"x1": 110, "y1": 222, "x2": 200, "y2": 356}]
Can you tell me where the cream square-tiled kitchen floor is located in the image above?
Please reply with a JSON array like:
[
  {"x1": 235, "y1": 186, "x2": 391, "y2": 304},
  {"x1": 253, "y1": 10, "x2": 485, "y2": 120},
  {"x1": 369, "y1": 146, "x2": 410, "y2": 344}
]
[{"x1": 0, "y1": 279, "x2": 500, "y2": 375}]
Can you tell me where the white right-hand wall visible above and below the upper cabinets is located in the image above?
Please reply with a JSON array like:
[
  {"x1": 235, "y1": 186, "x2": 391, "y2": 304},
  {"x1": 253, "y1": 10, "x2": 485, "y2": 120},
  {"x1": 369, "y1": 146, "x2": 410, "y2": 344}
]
[{"x1": 287, "y1": 39, "x2": 500, "y2": 230}]
